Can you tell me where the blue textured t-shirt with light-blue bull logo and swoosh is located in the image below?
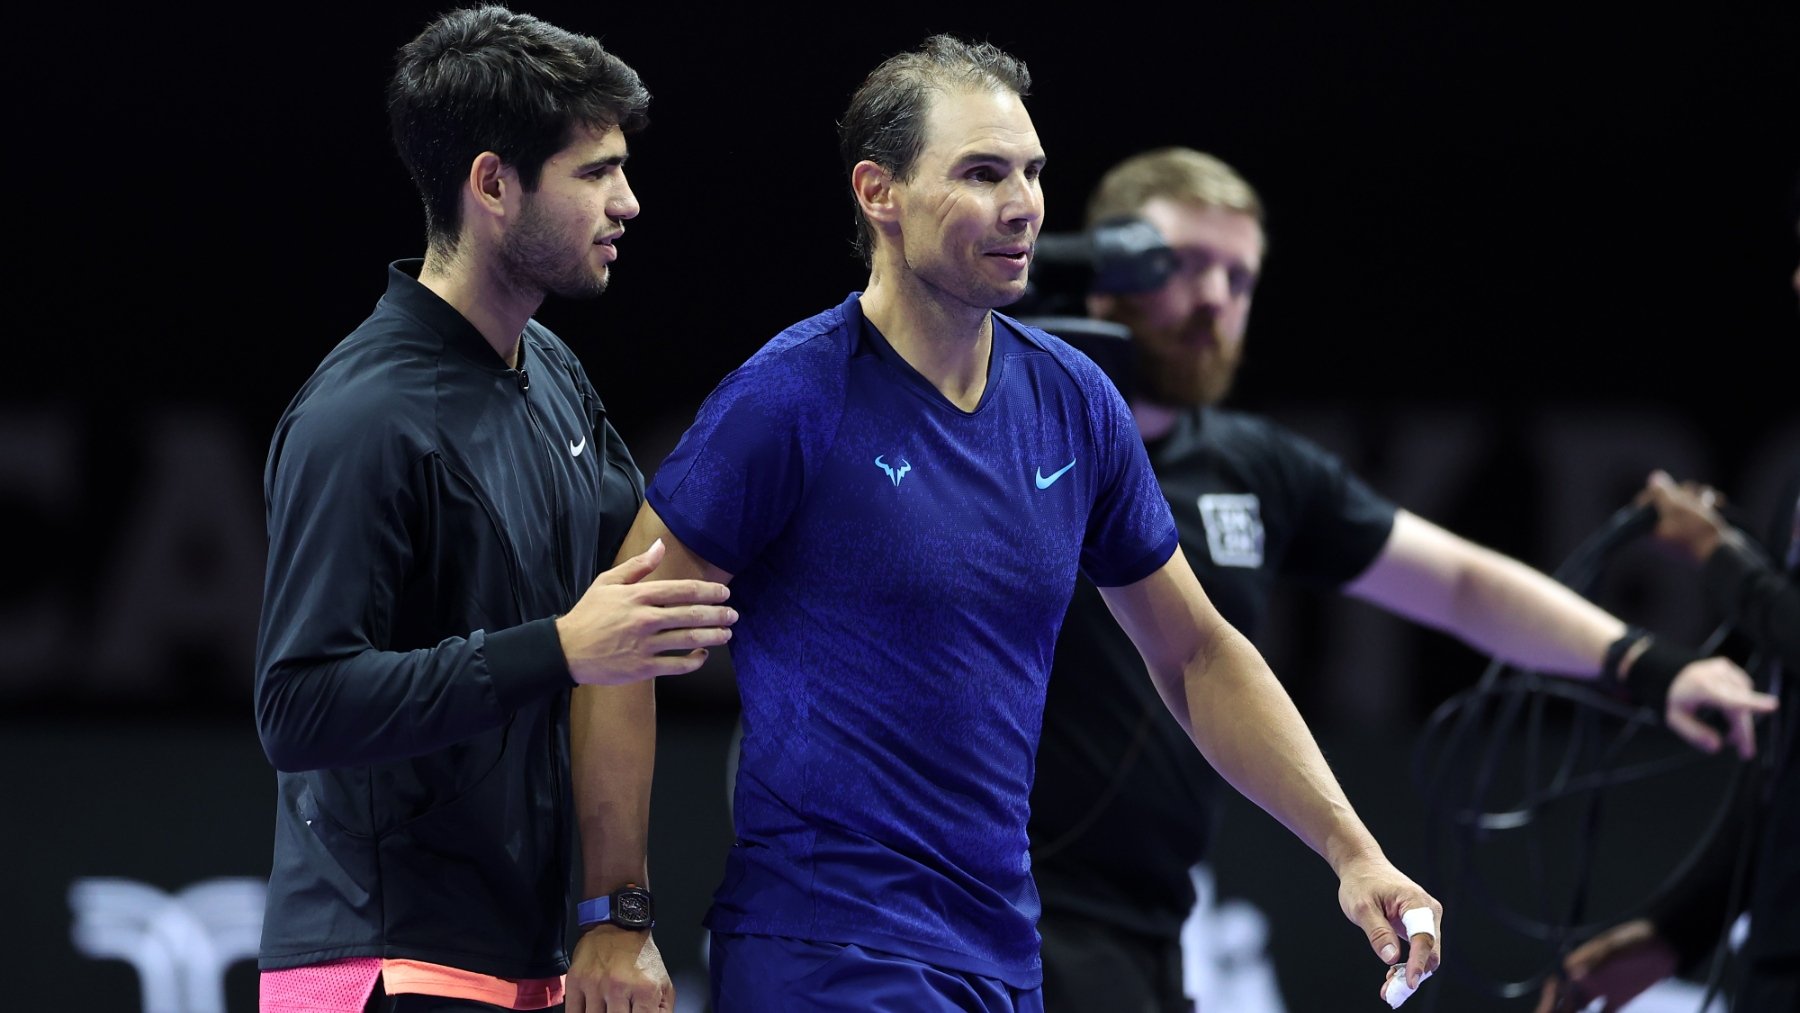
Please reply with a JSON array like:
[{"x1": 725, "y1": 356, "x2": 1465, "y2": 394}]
[{"x1": 648, "y1": 293, "x2": 1175, "y2": 988}]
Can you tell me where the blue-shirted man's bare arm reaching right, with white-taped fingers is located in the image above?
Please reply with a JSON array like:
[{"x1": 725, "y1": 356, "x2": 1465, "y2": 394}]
[{"x1": 1100, "y1": 552, "x2": 1444, "y2": 986}]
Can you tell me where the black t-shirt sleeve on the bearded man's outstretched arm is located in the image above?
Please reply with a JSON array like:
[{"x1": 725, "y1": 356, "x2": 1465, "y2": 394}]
[{"x1": 1276, "y1": 432, "x2": 1395, "y2": 588}]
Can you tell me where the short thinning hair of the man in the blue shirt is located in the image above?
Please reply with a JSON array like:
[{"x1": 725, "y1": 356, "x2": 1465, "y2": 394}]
[{"x1": 837, "y1": 36, "x2": 1031, "y2": 264}]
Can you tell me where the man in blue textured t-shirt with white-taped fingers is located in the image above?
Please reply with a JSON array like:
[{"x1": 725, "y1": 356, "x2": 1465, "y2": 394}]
[{"x1": 576, "y1": 36, "x2": 1442, "y2": 1011}]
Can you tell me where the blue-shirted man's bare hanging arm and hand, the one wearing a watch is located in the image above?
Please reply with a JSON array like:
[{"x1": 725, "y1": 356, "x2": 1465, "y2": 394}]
[{"x1": 567, "y1": 504, "x2": 731, "y2": 1013}]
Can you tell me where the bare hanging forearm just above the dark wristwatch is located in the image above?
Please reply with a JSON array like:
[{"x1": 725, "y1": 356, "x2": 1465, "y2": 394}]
[{"x1": 569, "y1": 682, "x2": 657, "y2": 898}]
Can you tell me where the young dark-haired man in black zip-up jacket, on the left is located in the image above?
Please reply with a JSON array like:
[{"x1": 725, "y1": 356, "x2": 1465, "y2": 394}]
[{"x1": 256, "y1": 7, "x2": 736, "y2": 1013}]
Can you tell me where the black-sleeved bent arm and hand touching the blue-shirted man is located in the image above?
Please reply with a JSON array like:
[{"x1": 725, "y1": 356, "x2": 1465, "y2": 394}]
[{"x1": 256, "y1": 419, "x2": 729, "y2": 770}]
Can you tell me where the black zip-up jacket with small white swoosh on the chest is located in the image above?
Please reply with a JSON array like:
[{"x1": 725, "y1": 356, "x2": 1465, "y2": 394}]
[{"x1": 256, "y1": 261, "x2": 643, "y2": 977}]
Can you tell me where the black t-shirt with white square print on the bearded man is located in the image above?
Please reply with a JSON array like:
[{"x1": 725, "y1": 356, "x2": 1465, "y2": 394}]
[{"x1": 1031, "y1": 408, "x2": 1395, "y2": 936}]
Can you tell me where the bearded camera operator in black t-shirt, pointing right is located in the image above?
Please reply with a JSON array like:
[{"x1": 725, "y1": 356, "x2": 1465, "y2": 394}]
[{"x1": 1030, "y1": 148, "x2": 1775, "y2": 1013}]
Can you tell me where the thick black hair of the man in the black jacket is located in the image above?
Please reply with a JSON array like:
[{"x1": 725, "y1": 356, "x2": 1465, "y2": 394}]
[{"x1": 387, "y1": 5, "x2": 650, "y2": 252}]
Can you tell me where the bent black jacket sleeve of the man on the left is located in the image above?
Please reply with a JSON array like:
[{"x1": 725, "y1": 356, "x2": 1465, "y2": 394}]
[{"x1": 256, "y1": 395, "x2": 571, "y2": 770}]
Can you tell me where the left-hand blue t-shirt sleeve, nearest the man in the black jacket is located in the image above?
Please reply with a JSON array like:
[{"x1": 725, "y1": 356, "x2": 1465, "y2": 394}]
[{"x1": 646, "y1": 358, "x2": 815, "y2": 574}]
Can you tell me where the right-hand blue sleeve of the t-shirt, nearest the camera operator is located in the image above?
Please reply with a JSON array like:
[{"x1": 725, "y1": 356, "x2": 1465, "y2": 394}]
[{"x1": 1082, "y1": 369, "x2": 1181, "y2": 587}]
